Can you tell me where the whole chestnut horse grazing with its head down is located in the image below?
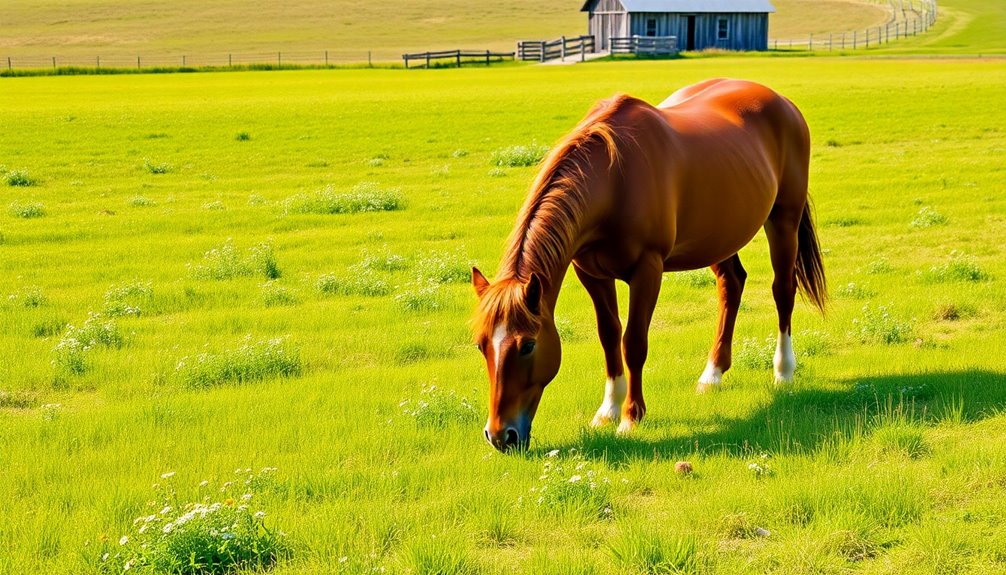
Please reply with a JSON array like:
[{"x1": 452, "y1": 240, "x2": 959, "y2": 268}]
[{"x1": 472, "y1": 79, "x2": 827, "y2": 450}]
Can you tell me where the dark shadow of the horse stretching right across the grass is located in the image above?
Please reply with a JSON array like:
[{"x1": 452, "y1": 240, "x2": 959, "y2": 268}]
[{"x1": 529, "y1": 370, "x2": 1006, "y2": 465}]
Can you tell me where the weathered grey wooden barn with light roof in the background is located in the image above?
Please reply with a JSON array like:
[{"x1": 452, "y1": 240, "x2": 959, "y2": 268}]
[{"x1": 581, "y1": 0, "x2": 776, "y2": 50}]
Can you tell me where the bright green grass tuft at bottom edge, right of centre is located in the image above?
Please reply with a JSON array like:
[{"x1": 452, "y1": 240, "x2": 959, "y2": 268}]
[{"x1": 609, "y1": 528, "x2": 703, "y2": 575}]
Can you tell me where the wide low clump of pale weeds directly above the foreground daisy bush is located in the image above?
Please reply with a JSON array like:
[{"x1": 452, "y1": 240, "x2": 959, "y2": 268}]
[{"x1": 175, "y1": 338, "x2": 302, "y2": 389}]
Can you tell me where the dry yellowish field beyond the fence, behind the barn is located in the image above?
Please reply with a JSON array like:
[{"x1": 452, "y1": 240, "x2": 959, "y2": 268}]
[{"x1": 0, "y1": 0, "x2": 886, "y2": 61}]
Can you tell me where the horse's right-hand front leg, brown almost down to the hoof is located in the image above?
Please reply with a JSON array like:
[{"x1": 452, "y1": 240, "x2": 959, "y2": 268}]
[{"x1": 619, "y1": 252, "x2": 664, "y2": 433}]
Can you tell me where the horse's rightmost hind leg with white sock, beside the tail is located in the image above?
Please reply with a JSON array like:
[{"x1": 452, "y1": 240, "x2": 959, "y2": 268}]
[{"x1": 765, "y1": 202, "x2": 804, "y2": 383}]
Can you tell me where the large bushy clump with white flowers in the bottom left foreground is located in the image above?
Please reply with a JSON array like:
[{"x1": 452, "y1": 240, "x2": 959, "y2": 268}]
[{"x1": 99, "y1": 467, "x2": 291, "y2": 575}]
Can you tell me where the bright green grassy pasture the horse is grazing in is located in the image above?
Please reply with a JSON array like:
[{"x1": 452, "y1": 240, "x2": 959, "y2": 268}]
[{"x1": 0, "y1": 53, "x2": 1006, "y2": 574}]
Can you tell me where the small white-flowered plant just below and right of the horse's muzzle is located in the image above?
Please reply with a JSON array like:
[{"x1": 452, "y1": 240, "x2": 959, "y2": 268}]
[{"x1": 530, "y1": 450, "x2": 613, "y2": 518}]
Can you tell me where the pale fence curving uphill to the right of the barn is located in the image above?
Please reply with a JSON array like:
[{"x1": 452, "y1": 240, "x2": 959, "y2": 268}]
[{"x1": 769, "y1": 0, "x2": 937, "y2": 51}]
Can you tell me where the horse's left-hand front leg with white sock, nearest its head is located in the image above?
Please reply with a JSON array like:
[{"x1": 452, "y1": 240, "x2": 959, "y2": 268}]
[{"x1": 573, "y1": 266, "x2": 627, "y2": 427}]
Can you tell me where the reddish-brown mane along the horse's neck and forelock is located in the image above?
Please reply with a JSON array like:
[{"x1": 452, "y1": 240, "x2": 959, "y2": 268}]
[{"x1": 473, "y1": 94, "x2": 631, "y2": 333}]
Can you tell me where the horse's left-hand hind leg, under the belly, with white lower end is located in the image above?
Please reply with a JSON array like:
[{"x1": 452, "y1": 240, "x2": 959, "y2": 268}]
[{"x1": 696, "y1": 254, "x2": 747, "y2": 393}]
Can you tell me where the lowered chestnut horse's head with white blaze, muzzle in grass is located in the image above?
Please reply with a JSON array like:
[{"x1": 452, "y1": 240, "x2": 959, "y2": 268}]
[{"x1": 472, "y1": 268, "x2": 561, "y2": 451}]
